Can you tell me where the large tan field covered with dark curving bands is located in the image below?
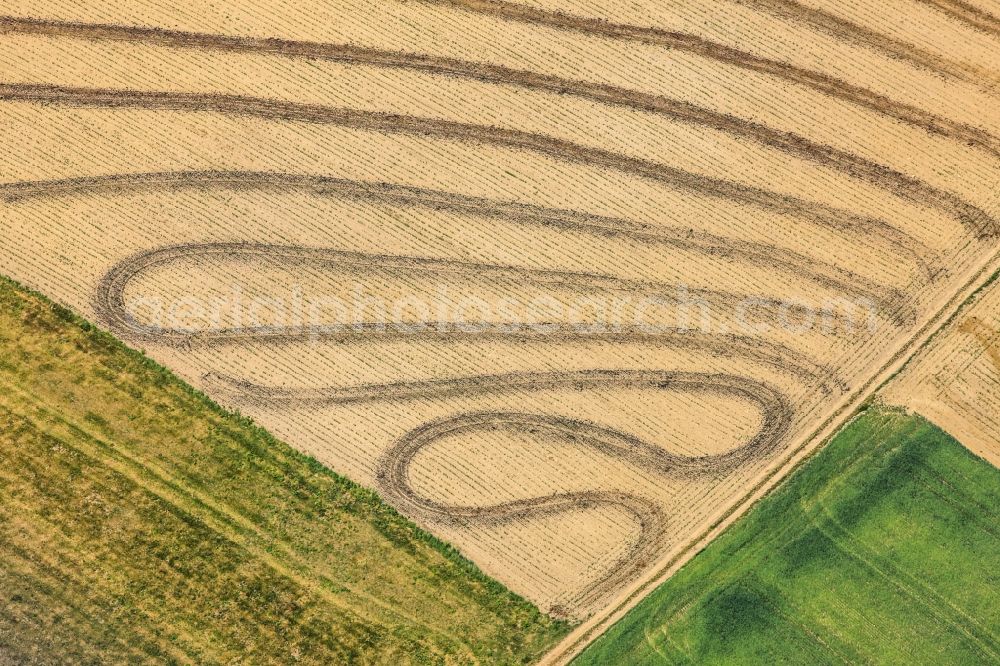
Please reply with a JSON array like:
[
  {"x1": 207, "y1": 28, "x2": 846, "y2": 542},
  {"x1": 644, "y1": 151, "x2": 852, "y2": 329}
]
[{"x1": 0, "y1": 0, "x2": 1000, "y2": 618}]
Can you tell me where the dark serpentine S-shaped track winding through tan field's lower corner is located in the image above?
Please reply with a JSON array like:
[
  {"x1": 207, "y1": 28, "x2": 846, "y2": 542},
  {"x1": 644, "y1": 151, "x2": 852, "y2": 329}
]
[{"x1": 209, "y1": 370, "x2": 794, "y2": 608}]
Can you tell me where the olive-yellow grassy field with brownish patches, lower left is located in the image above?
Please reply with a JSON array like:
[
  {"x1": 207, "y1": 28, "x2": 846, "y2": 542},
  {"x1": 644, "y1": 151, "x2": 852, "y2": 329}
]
[{"x1": 0, "y1": 280, "x2": 567, "y2": 664}]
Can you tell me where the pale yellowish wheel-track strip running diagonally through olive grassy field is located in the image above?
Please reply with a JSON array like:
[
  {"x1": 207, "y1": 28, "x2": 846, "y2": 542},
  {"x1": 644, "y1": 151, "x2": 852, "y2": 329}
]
[{"x1": 0, "y1": 374, "x2": 478, "y2": 663}]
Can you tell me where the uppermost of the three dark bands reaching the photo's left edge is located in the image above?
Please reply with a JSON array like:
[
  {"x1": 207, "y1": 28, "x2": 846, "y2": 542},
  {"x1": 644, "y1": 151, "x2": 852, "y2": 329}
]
[{"x1": 0, "y1": 18, "x2": 1000, "y2": 241}]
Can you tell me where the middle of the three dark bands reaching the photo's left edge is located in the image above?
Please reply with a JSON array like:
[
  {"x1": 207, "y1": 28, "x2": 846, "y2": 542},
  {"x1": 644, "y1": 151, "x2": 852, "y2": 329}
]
[{"x1": 0, "y1": 83, "x2": 1000, "y2": 244}]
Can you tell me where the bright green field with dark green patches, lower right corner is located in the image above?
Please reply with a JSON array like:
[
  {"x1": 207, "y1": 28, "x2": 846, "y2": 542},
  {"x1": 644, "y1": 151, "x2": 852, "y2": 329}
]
[{"x1": 574, "y1": 408, "x2": 1000, "y2": 666}]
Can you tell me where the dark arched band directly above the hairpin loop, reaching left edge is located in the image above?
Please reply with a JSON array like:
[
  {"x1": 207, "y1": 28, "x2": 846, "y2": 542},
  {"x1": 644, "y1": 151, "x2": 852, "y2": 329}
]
[{"x1": 0, "y1": 171, "x2": 916, "y2": 308}]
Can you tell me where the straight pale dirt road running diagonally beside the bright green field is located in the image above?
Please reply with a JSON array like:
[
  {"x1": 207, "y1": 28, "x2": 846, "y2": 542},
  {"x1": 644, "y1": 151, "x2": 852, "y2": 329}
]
[{"x1": 538, "y1": 245, "x2": 1000, "y2": 666}]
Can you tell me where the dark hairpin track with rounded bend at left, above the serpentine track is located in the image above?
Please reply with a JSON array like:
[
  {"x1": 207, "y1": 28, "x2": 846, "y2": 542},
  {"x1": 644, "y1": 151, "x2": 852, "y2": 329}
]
[{"x1": 94, "y1": 242, "x2": 841, "y2": 392}]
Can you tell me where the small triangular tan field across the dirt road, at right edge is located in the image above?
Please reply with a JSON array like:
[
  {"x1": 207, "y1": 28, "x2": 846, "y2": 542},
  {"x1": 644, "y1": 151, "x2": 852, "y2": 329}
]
[{"x1": 881, "y1": 276, "x2": 1000, "y2": 467}]
